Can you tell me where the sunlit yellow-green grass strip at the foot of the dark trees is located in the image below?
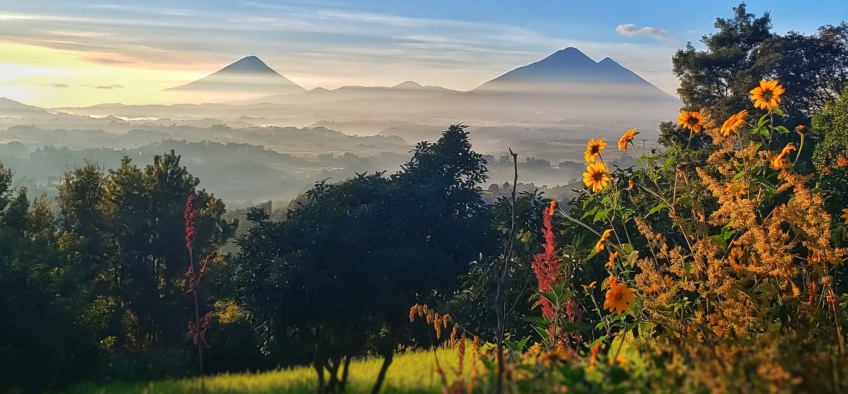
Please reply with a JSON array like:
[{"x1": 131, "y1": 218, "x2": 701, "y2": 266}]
[{"x1": 65, "y1": 349, "x2": 458, "y2": 394}]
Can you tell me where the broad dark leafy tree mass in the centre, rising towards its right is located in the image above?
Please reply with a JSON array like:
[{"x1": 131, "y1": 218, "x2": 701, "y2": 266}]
[{"x1": 236, "y1": 126, "x2": 492, "y2": 391}]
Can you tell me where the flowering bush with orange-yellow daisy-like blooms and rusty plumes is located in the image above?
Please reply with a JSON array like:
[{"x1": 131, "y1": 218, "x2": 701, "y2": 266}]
[{"x1": 450, "y1": 81, "x2": 848, "y2": 392}]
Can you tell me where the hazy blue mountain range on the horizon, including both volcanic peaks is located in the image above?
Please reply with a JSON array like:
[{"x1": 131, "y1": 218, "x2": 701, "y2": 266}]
[{"x1": 169, "y1": 47, "x2": 674, "y2": 104}]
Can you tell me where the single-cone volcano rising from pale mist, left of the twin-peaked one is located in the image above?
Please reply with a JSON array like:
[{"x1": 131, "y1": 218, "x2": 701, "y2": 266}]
[{"x1": 167, "y1": 56, "x2": 306, "y2": 95}]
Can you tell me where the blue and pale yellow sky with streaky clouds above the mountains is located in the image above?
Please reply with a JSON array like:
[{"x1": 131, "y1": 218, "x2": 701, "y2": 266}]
[{"x1": 0, "y1": 0, "x2": 848, "y2": 107}]
